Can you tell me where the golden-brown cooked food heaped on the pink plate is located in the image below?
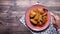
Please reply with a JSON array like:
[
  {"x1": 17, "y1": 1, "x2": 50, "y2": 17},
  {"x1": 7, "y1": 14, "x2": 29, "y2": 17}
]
[{"x1": 29, "y1": 8, "x2": 47, "y2": 26}]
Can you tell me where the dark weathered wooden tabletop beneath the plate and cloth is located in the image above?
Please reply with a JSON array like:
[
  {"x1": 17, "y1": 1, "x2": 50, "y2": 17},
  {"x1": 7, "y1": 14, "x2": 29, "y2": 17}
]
[{"x1": 0, "y1": 0, "x2": 60, "y2": 34}]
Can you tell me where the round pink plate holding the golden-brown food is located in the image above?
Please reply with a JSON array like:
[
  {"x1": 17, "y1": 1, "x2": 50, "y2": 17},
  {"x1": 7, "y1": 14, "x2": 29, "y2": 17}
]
[{"x1": 25, "y1": 4, "x2": 51, "y2": 31}]
